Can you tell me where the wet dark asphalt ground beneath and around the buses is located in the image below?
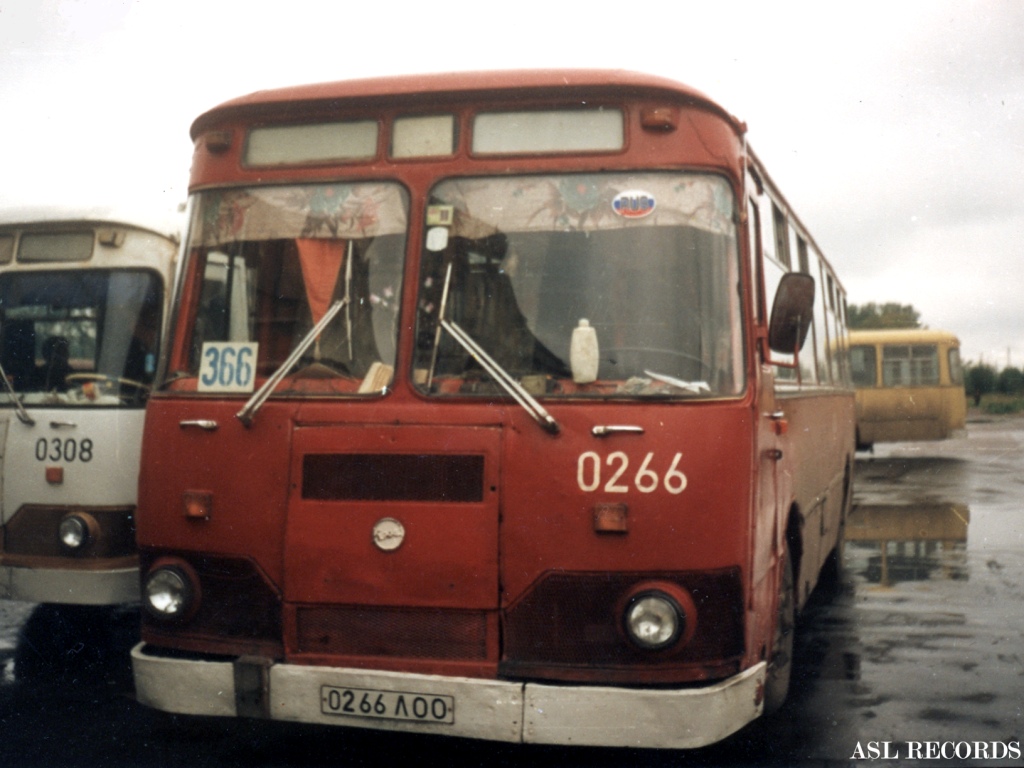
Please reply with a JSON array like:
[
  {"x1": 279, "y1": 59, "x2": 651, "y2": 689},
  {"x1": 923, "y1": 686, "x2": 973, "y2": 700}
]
[{"x1": 0, "y1": 416, "x2": 1024, "y2": 768}]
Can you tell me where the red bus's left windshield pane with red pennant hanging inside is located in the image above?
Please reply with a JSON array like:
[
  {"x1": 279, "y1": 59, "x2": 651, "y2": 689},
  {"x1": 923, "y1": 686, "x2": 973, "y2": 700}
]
[{"x1": 178, "y1": 182, "x2": 409, "y2": 394}]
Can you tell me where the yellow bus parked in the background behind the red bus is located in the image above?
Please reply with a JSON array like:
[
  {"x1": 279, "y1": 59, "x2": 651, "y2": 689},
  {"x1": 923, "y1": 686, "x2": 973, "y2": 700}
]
[{"x1": 850, "y1": 329, "x2": 967, "y2": 451}]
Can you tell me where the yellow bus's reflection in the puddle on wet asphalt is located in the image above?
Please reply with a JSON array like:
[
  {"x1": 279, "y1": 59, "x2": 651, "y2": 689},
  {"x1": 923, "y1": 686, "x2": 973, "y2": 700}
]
[{"x1": 846, "y1": 502, "x2": 971, "y2": 587}]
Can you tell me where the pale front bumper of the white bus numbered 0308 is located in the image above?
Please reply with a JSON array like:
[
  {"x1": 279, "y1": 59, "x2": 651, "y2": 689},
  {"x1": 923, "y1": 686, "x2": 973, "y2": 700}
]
[{"x1": 0, "y1": 565, "x2": 139, "y2": 605}]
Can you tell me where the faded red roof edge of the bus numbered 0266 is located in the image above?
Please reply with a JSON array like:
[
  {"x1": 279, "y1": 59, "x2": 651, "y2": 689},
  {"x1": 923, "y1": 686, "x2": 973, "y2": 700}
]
[{"x1": 191, "y1": 70, "x2": 745, "y2": 139}]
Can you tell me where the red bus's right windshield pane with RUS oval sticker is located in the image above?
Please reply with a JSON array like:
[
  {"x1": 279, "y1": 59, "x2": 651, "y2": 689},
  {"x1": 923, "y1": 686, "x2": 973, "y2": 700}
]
[{"x1": 415, "y1": 173, "x2": 743, "y2": 397}]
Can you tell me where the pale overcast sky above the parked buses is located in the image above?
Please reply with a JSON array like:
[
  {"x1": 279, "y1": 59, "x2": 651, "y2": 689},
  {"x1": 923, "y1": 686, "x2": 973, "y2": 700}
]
[{"x1": 0, "y1": 0, "x2": 1024, "y2": 367}]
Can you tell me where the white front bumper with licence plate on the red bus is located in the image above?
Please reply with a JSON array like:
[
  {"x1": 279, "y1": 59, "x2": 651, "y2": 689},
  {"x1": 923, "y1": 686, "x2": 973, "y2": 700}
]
[{"x1": 132, "y1": 644, "x2": 766, "y2": 749}]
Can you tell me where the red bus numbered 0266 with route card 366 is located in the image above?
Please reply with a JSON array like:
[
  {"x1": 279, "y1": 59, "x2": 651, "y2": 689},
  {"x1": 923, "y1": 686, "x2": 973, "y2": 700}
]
[{"x1": 132, "y1": 71, "x2": 854, "y2": 748}]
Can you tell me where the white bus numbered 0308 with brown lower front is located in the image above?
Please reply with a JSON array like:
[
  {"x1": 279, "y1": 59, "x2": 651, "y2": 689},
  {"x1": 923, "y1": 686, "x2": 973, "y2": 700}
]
[{"x1": 0, "y1": 210, "x2": 180, "y2": 605}]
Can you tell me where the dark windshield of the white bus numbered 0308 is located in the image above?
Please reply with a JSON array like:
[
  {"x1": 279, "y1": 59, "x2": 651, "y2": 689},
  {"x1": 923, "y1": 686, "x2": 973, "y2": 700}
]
[{"x1": 0, "y1": 269, "x2": 163, "y2": 407}]
